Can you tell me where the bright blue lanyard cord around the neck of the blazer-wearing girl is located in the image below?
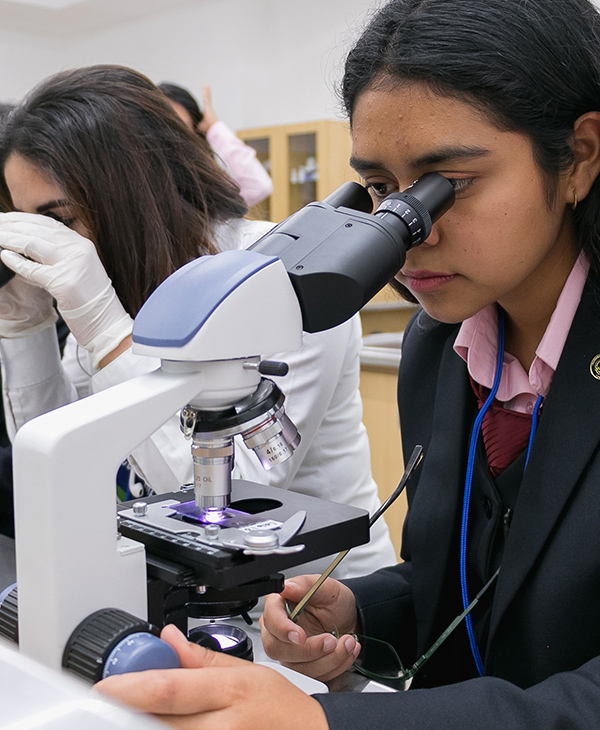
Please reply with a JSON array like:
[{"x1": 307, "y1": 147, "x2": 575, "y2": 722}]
[{"x1": 460, "y1": 307, "x2": 543, "y2": 677}]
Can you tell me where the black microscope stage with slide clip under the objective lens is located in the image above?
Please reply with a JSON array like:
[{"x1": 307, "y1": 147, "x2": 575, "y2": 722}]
[{"x1": 119, "y1": 480, "x2": 369, "y2": 589}]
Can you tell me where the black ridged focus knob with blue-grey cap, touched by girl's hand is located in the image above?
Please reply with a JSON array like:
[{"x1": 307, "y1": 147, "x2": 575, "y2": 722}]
[{"x1": 63, "y1": 608, "x2": 180, "y2": 683}]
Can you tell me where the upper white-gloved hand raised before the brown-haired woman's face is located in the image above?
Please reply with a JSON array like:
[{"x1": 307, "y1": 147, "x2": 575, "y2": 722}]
[{"x1": 0, "y1": 213, "x2": 133, "y2": 368}]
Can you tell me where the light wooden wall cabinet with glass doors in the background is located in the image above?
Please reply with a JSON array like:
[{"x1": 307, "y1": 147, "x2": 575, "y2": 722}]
[{"x1": 237, "y1": 119, "x2": 359, "y2": 223}]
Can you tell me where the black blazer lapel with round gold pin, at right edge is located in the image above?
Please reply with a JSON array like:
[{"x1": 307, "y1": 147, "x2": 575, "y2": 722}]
[{"x1": 488, "y1": 292, "x2": 600, "y2": 648}]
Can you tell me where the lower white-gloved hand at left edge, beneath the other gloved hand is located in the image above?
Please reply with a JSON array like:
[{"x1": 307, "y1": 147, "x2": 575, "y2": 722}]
[{"x1": 0, "y1": 268, "x2": 58, "y2": 338}]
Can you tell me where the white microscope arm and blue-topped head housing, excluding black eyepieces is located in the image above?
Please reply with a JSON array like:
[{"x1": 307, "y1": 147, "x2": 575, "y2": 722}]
[{"x1": 14, "y1": 251, "x2": 302, "y2": 668}]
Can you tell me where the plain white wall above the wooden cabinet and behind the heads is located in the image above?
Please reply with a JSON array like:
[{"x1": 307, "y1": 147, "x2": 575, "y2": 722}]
[{"x1": 0, "y1": 0, "x2": 381, "y2": 129}]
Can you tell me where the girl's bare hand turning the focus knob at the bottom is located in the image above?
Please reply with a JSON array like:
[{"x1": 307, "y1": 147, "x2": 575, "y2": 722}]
[{"x1": 96, "y1": 626, "x2": 328, "y2": 730}]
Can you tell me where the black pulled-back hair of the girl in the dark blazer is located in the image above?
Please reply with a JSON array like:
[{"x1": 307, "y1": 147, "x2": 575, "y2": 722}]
[{"x1": 341, "y1": 0, "x2": 600, "y2": 301}]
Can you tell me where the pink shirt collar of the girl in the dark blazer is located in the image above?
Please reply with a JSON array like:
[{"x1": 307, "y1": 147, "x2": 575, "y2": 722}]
[{"x1": 454, "y1": 252, "x2": 589, "y2": 413}]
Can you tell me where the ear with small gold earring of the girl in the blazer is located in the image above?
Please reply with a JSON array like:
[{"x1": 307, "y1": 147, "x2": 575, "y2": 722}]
[{"x1": 566, "y1": 112, "x2": 600, "y2": 204}]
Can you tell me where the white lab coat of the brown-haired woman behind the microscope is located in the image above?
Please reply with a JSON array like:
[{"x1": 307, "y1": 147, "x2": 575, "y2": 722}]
[{"x1": 0, "y1": 220, "x2": 396, "y2": 578}]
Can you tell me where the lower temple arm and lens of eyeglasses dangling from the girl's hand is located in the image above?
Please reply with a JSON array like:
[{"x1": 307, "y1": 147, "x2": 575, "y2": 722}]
[{"x1": 326, "y1": 568, "x2": 500, "y2": 689}]
